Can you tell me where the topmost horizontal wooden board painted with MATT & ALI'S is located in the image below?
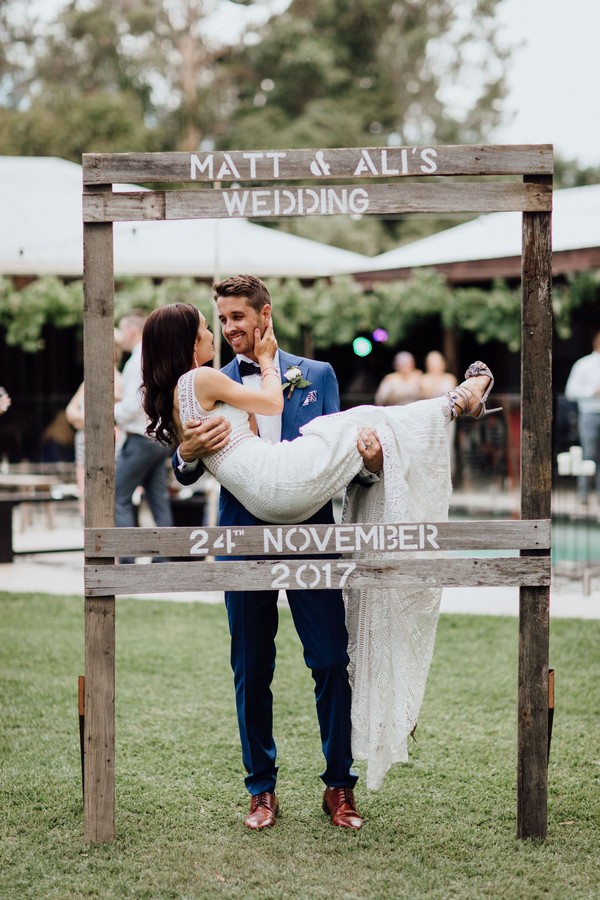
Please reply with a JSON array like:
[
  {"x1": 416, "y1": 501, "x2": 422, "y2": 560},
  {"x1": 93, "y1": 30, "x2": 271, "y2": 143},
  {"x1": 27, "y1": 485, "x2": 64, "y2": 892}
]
[{"x1": 83, "y1": 144, "x2": 554, "y2": 184}]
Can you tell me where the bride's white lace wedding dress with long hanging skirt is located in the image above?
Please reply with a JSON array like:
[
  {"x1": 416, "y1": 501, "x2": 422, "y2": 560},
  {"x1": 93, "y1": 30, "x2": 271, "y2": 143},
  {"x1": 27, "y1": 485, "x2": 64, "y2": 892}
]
[{"x1": 178, "y1": 370, "x2": 451, "y2": 788}]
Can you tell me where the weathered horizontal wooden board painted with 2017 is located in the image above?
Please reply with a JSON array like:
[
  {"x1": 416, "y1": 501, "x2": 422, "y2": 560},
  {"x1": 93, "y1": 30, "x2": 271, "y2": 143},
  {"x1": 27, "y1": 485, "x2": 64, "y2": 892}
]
[{"x1": 84, "y1": 556, "x2": 551, "y2": 597}]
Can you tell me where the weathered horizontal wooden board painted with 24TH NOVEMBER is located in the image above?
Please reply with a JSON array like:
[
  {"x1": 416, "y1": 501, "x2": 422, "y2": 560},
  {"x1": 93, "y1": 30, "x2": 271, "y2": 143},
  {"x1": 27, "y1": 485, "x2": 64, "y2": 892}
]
[{"x1": 85, "y1": 519, "x2": 551, "y2": 559}]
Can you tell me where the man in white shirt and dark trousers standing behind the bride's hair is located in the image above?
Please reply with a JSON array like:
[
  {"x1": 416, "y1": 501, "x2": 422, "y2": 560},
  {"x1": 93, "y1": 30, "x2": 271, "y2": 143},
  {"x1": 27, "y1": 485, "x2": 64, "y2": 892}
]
[{"x1": 115, "y1": 310, "x2": 173, "y2": 563}]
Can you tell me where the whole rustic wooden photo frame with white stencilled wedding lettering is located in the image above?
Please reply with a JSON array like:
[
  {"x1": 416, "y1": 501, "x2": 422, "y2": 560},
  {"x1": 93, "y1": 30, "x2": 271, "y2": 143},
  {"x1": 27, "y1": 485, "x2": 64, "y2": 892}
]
[{"x1": 83, "y1": 145, "x2": 553, "y2": 843}]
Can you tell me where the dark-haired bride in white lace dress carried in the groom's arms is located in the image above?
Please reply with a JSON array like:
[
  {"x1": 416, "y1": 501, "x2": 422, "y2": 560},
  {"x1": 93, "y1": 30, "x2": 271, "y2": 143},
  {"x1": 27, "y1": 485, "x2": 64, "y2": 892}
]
[{"x1": 142, "y1": 303, "x2": 494, "y2": 788}]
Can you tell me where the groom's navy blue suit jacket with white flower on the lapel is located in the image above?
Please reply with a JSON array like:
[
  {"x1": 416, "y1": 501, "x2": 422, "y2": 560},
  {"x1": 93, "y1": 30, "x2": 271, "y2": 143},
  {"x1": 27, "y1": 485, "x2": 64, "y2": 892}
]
[{"x1": 173, "y1": 350, "x2": 340, "y2": 525}]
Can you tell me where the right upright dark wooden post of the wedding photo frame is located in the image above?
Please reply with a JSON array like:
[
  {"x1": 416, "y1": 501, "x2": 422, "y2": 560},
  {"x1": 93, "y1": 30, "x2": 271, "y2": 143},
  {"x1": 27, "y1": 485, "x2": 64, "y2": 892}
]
[{"x1": 517, "y1": 176, "x2": 552, "y2": 838}]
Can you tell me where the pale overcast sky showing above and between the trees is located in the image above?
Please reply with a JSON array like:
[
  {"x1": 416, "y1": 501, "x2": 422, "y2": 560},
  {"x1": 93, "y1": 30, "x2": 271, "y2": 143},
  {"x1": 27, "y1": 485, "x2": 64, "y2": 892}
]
[{"x1": 26, "y1": 0, "x2": 600, "y2": 166}]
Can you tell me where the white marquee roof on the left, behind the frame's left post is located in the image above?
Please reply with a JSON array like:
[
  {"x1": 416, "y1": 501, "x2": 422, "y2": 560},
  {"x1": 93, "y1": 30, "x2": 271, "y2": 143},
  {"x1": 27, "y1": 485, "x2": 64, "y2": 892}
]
[{"x1": 0, "y1": 156, "x2": 370, "y2": 278}]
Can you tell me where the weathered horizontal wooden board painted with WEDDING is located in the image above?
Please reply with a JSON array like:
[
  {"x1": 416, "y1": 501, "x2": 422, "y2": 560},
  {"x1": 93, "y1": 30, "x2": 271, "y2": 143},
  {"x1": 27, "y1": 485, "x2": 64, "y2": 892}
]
[{"x1": 83, "y1": 181, "x2": 552, "y2": 223}]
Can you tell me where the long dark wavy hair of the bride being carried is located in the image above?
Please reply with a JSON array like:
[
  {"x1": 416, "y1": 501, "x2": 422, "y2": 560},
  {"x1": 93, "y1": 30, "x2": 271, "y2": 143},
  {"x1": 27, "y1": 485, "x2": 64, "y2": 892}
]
[{"x1": 142, "y1": 303, "x2": 200, "y2": 445}]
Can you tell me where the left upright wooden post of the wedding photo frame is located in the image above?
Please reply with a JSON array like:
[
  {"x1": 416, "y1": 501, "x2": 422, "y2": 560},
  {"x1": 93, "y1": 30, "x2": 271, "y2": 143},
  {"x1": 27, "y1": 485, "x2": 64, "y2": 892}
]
[{"x1": 84, "y1": 186, "x2": 115, "y2": 843}]
